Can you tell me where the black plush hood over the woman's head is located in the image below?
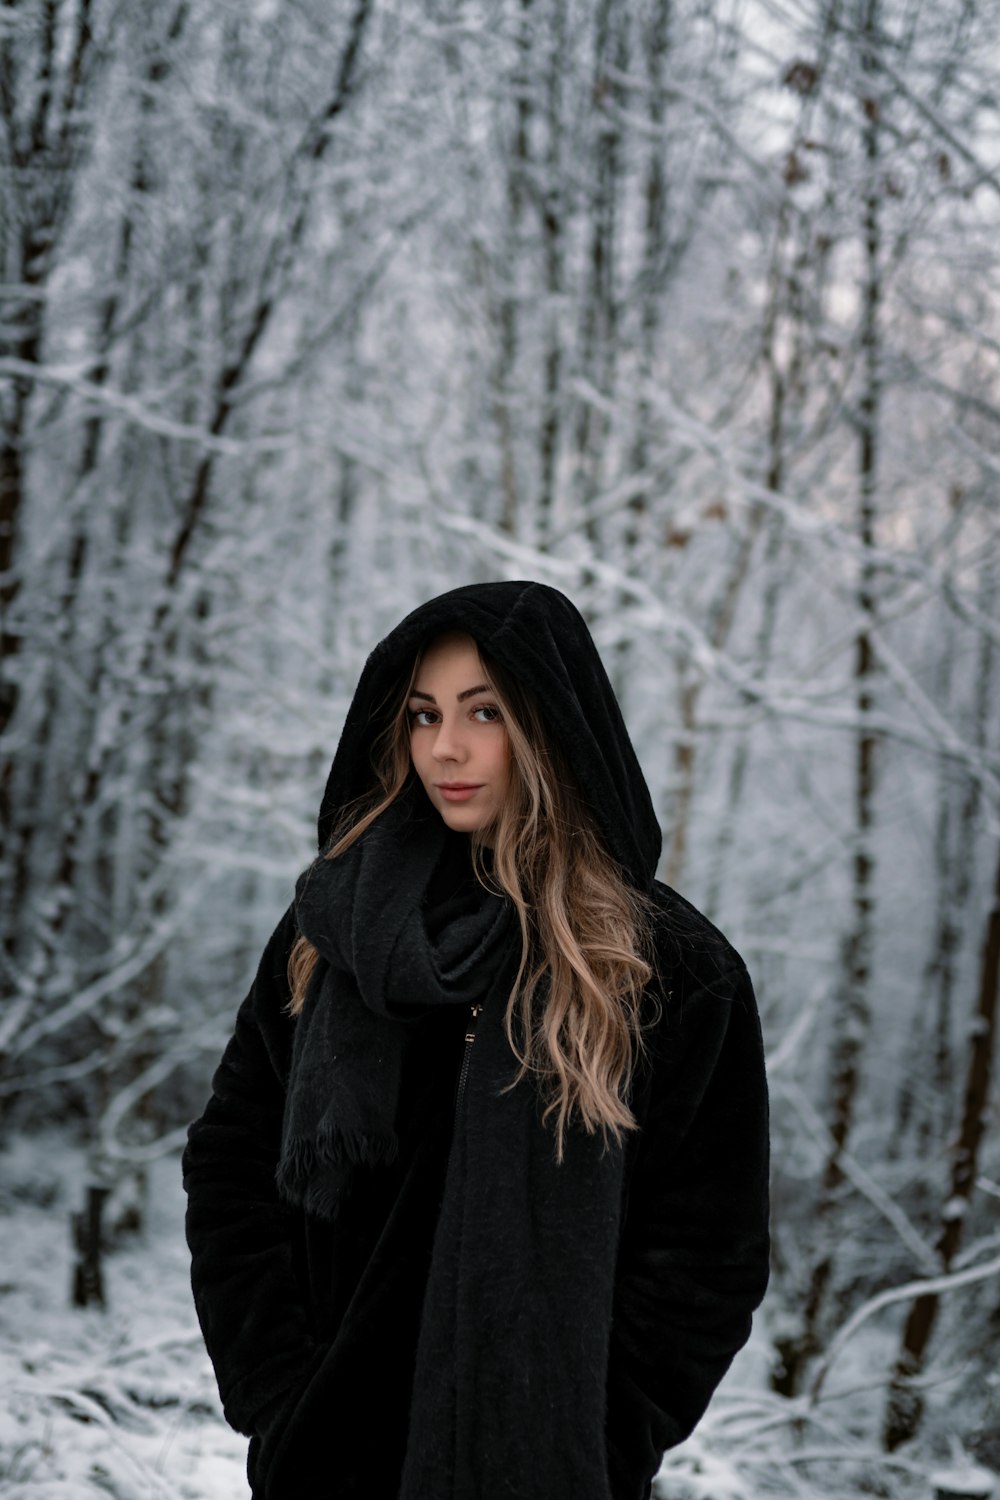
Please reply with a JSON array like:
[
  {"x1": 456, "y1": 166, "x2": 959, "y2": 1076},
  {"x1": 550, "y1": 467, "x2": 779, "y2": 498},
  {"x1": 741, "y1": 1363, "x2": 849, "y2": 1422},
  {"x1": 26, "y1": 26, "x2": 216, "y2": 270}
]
[{"x1": 319, "y1": 581, "x2": 661, "y2": 890}]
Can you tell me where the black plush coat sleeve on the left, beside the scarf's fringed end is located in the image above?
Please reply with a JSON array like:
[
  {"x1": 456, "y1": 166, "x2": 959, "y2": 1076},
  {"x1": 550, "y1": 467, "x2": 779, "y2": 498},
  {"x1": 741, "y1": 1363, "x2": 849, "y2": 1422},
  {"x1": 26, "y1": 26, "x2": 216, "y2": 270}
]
[{"x1": 183, "y1": 908, "x2": 322, "y2": 1434}]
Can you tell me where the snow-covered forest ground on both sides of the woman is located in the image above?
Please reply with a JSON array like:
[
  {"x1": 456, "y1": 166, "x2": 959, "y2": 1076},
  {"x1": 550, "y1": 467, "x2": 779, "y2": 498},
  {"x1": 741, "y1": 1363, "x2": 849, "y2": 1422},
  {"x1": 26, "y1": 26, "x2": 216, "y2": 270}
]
[{"x1": 0, "y1": 1137, "x2": 971, "y2": 1500}]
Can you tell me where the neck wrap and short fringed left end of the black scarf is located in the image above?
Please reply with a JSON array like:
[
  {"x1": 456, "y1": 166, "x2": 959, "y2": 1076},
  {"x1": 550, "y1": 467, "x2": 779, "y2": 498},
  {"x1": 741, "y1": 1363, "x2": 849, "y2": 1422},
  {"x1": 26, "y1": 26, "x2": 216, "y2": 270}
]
[{"x1": 277, "y1": 786, "x2": 517, "y2": 1218}]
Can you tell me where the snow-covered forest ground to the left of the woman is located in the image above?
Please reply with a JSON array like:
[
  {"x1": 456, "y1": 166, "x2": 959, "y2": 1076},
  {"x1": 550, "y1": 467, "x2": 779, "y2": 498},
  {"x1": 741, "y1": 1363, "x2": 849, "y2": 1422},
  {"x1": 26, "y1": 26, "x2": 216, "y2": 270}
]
[{"x1": 0, "y1": 1134, "x2": 249, "y2": 1500}]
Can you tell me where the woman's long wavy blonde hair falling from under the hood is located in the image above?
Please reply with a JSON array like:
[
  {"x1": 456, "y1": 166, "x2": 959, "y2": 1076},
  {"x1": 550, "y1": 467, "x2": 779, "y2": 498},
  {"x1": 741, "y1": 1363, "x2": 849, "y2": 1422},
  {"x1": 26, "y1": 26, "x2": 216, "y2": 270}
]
[{"x1": 288, "y1": 642, "x2": 654, "y2": 1161}]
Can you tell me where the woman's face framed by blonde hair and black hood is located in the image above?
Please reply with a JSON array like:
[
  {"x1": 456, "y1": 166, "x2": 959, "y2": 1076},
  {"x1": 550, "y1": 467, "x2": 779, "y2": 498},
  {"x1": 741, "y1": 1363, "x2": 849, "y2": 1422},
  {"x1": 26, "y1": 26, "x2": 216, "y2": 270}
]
[{"x1": 406, "y1": 635, "x2": 510, "y2": 834}]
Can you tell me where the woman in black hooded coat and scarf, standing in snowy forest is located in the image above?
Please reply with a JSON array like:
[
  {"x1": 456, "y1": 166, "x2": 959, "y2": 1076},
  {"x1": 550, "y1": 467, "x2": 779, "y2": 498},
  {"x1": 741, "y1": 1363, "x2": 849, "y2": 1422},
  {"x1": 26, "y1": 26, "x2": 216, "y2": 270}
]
[{"x1": 184, "y1": 582, "x2": 768, "y2": 1500}]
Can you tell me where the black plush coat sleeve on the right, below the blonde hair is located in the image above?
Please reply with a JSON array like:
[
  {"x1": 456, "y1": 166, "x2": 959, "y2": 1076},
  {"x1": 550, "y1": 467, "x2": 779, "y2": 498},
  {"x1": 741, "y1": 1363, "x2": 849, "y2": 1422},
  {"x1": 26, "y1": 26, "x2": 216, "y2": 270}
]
[{"x1": 607, "y1": 950, "x2": 769, "y2": 1500}]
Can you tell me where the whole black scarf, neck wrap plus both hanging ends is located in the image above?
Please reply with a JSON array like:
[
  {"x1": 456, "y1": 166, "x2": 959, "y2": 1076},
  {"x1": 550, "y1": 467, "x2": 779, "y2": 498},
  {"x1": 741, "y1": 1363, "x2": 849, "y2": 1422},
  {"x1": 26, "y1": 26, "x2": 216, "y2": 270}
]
[{"x1": 279, "y1": 789, "x2": 624, "y2": 1500}]
